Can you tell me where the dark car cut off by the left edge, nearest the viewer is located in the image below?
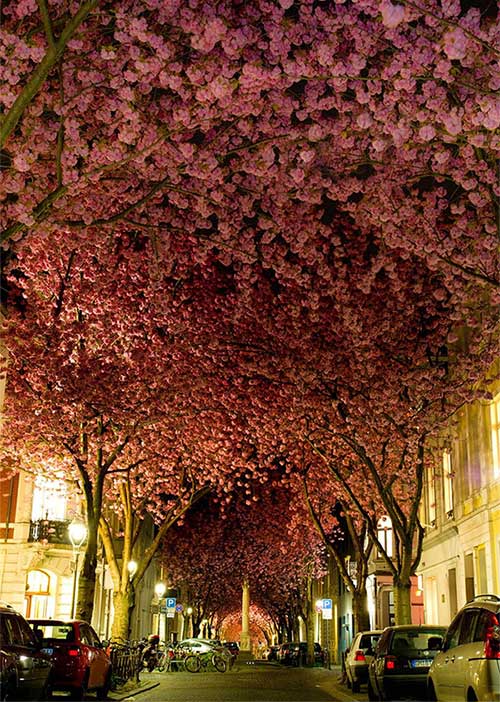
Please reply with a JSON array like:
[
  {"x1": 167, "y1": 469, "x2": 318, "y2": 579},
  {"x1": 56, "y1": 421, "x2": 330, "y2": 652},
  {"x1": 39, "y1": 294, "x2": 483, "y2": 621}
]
[{"x1": 0, "y1": 603, "x2": 51, "y2": 700}]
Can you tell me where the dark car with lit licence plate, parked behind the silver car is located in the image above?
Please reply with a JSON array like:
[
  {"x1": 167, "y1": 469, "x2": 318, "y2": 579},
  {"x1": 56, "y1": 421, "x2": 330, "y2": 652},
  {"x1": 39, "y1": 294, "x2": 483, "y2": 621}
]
[{"x1": 368, "y1": 624, "x2": 446, "y2": 700}]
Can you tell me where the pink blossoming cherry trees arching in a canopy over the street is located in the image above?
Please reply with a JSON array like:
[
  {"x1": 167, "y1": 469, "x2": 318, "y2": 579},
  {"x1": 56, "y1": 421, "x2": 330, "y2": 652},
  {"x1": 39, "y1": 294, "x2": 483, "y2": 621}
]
[{"x1": 0, "y1": 0, "x2": 500, "y2": 636}]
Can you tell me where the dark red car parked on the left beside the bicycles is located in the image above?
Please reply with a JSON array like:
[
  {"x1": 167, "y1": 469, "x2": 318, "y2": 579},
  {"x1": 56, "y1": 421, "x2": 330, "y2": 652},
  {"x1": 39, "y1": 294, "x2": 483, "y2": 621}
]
[{"x1": 29, "y1": 619, "x2": 111, "y2": 700}]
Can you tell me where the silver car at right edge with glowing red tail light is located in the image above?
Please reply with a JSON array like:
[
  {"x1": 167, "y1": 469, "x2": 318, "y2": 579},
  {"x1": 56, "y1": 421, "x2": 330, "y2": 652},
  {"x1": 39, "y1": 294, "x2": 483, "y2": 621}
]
[{"x1": 427, "y1": 595, "x2": 500, "y2": 701}]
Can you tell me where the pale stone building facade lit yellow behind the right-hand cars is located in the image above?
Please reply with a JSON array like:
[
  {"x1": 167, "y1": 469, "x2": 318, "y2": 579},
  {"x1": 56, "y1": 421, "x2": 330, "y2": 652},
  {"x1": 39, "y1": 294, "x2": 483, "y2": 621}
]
[{"x1": 419, "y1": 386, "x2": 500, "y2": 624}]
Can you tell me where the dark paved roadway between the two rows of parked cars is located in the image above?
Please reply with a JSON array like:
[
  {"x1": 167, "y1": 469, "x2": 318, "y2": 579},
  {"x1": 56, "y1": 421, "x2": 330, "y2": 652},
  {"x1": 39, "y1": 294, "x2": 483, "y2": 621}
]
[{"x1": 116, "y1": 661, "x2": 367, "y2": 702}]
